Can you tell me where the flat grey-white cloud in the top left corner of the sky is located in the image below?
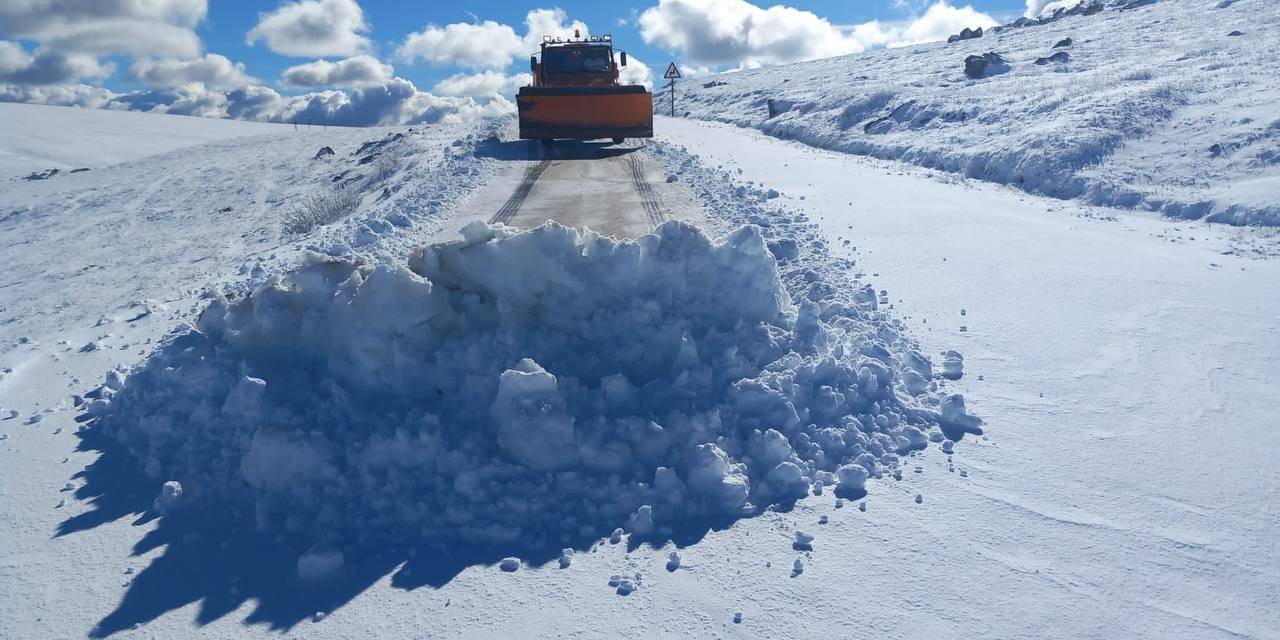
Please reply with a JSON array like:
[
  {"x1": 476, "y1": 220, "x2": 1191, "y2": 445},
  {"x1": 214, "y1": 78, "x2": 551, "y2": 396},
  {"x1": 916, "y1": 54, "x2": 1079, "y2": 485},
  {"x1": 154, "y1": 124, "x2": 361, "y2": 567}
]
[{"x1": 0, "y1": 0, "x2": 209, "y2": 58}]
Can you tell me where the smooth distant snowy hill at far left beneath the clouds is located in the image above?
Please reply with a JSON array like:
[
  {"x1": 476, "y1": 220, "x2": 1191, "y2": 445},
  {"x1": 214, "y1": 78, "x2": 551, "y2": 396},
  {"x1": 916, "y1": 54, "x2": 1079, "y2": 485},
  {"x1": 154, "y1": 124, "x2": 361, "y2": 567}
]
[{"x1": 0, "y1": 102, "x2": 293, "y2": 180}]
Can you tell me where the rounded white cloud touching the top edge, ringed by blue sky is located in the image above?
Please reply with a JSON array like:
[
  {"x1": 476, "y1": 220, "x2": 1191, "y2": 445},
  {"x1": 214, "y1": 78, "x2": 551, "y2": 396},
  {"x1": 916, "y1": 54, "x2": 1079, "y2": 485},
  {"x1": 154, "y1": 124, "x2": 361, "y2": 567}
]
[{"x1": 247, "y1": 0, "x2": 371, "y2": 58}]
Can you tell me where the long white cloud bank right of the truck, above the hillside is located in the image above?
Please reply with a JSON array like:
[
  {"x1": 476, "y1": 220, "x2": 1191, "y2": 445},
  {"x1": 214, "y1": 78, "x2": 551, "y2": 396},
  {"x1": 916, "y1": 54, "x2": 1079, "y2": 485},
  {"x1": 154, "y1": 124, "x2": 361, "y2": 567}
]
[{"x1": 639, "y1": 0, "x2": 996, "y2": 67}]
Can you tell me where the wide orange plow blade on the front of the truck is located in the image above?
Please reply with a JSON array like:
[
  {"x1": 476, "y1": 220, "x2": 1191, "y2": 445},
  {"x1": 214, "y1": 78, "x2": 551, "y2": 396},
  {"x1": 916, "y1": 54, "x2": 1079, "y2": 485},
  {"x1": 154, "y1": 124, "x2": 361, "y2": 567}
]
[{"x1": 516, "y1": 84, "x2": 653, "y2": 140}]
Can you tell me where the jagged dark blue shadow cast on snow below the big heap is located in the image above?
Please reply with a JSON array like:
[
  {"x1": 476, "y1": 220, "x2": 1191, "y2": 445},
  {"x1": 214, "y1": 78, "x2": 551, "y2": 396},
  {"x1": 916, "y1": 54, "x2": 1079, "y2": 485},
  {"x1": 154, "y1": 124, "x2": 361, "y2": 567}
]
[{"x1": 56, "y1": 416, "x2": 742, "y2": 637}]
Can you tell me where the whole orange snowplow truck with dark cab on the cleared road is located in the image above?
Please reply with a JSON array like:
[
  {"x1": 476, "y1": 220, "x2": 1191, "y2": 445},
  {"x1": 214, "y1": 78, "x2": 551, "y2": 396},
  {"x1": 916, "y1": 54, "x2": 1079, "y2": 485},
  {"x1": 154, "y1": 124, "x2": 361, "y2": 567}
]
[{"x1": 516, "y1": 31, "x2": 653, "y2": 142}]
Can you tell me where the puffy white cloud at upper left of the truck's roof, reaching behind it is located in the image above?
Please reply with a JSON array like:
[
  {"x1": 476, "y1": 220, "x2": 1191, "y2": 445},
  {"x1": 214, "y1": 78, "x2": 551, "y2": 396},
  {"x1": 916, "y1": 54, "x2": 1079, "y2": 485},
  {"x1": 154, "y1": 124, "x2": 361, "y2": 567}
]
[{"x1": 397, "y1": 9, "x2": 589, "y2": 70}]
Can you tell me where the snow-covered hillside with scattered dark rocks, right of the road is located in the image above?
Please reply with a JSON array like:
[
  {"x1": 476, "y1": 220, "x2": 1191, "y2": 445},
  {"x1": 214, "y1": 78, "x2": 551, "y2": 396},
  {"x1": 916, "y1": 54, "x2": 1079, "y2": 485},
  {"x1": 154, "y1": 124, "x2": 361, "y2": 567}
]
[{"x1": 675, "y1": 0, "x2": 1280, "y2": 225}]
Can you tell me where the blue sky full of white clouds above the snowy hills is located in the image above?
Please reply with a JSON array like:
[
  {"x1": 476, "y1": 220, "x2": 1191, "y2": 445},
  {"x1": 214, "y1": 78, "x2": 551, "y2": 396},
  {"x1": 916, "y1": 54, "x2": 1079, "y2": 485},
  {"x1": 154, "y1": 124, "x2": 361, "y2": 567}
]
[{"x1": 0, "y1": 0, "x2": 1029, "y2": 125}]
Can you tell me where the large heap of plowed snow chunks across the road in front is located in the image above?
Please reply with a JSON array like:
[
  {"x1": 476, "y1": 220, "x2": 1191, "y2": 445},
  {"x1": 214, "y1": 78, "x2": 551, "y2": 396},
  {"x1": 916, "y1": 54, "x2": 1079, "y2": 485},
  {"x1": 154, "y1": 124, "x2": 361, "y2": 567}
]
[{"x1": 91, "y1": 221, "x2": 979, "y2": 548}]
